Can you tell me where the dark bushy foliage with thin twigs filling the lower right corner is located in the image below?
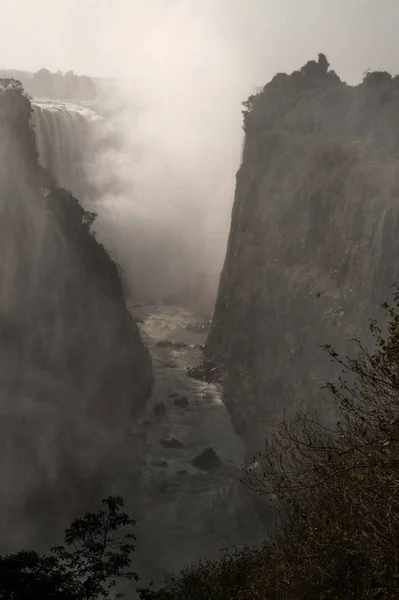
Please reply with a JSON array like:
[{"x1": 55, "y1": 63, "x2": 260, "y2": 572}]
[{"x1": 142, "y1": 288, "x2": 399, "y2": 600}]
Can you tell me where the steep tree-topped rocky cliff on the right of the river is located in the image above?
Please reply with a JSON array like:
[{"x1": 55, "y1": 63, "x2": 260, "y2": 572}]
[{"x1": 206, "y1": 55, "x2": 399, "y2": 450}]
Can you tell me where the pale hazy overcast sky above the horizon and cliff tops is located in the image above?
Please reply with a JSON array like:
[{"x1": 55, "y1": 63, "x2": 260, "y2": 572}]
[{"x1": 0, "y1": 0, "x2": 399, "y2": 85}]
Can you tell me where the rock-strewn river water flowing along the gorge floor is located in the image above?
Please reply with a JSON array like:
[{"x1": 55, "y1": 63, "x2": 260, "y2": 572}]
[{"x1": 123, "y1": 306, "x2": 262, "y2": 583}]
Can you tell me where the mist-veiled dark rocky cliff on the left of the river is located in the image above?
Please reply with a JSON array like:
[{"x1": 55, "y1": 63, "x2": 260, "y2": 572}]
[{"x1": 0, "y1": 80, "x2": 151, "y2": 547}]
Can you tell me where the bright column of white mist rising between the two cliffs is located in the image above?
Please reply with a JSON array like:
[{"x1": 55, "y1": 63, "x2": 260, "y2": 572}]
[{"x1": 83, "y1": 2, "x2": 272, "y2": 304}]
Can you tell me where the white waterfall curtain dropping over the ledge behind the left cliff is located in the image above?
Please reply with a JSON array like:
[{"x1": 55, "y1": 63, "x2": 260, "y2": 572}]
[{"x1": 32, "y1": 100, "x2": 100, "y2": 200}]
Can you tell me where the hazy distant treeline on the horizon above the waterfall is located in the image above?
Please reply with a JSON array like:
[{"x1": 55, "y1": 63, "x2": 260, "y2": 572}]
[{"x1": 0, "y1": 69, "x2": 98, "y2": 102}]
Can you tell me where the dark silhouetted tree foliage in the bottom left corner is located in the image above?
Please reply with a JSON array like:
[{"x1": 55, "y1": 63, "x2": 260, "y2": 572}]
[{"x1": 0, "y1": 496, "x2": 138, "y2": 600}]
